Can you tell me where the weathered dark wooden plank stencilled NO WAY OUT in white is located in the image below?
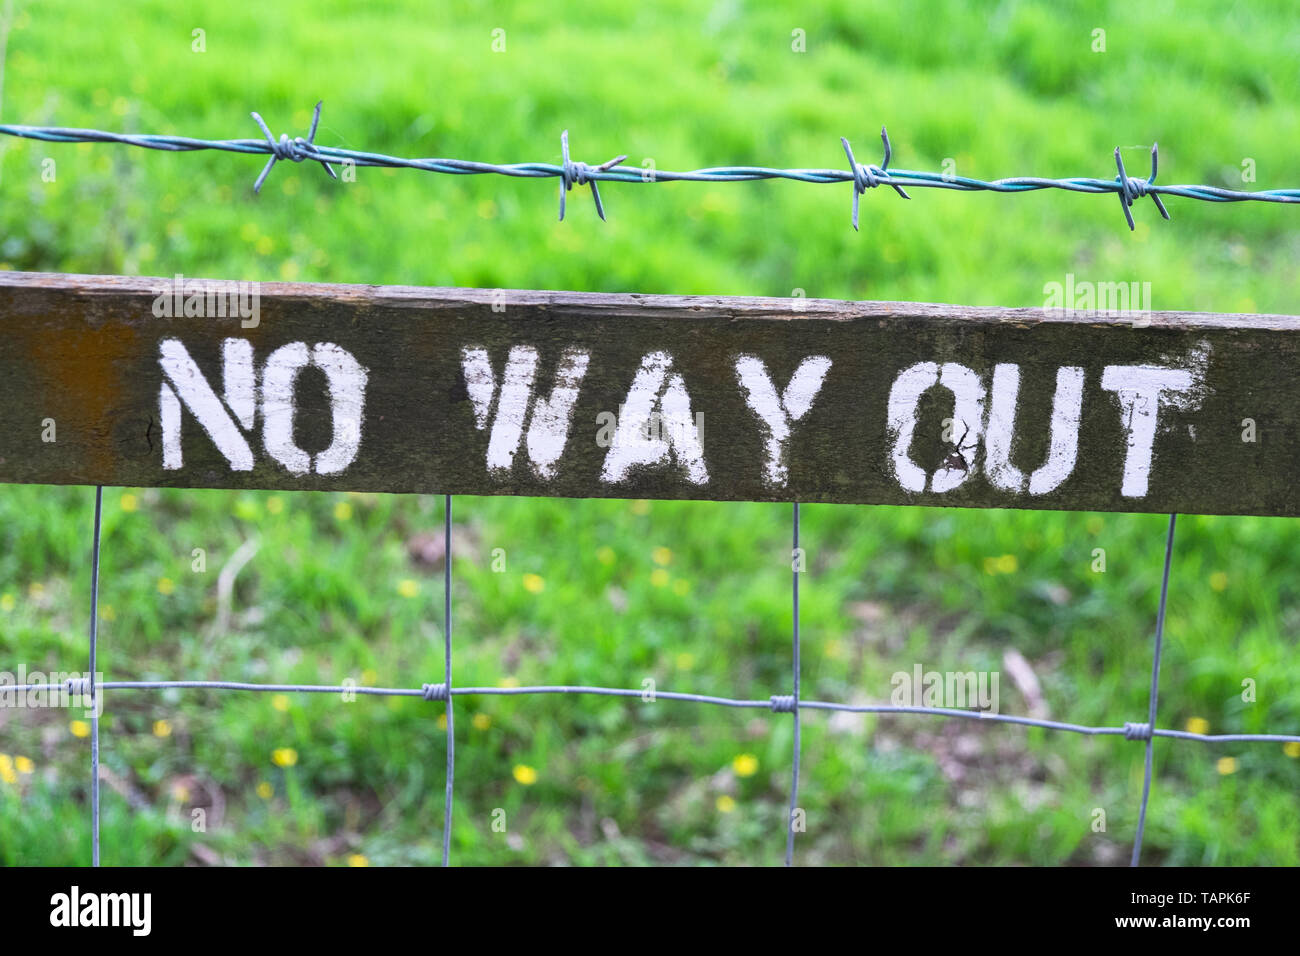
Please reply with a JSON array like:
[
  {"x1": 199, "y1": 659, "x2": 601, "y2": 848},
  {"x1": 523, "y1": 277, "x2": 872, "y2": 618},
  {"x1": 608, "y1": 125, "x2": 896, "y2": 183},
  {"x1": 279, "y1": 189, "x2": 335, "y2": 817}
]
[{"x1": 0, "y1": 273, "x2": 1300, "y2": 515}]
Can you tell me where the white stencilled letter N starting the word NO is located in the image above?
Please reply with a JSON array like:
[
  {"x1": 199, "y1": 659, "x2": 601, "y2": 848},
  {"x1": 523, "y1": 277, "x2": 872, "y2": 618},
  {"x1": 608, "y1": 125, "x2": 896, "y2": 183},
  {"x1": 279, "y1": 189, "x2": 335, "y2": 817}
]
[{"x1": 159, "y1": 338, "x2": 257, "y2": 471}]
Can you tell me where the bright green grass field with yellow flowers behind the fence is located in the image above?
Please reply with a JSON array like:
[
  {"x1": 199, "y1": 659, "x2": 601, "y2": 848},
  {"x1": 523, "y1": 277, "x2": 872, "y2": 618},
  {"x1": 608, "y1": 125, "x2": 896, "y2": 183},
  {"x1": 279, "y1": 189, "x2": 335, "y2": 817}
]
[{"x1": 0, "y1": 0, "x2": 1300, "y2": 865}]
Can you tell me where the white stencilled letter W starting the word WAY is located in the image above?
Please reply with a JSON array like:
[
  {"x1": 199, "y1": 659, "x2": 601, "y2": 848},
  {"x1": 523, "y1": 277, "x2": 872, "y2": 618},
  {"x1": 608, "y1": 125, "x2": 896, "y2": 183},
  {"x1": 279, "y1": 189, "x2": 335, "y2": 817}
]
[{"x1": 460, "y1": 345, "x2": 590, "y2": 479}]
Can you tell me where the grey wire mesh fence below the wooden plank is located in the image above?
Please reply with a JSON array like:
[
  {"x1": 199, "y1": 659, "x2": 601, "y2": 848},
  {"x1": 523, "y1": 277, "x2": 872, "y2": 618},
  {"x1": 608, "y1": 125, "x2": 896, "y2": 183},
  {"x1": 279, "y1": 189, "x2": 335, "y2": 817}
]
[{"x1": 0, "y1": 486, "x2": 1300, "y2": 866}]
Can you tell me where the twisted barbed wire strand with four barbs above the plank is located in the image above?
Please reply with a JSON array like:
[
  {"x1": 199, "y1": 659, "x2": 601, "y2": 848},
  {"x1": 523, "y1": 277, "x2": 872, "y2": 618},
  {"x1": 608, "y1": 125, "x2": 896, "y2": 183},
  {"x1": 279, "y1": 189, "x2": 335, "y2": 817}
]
[{"x1": 0, "y1": 103, "x2": 1300, "y2": 230}]
